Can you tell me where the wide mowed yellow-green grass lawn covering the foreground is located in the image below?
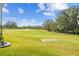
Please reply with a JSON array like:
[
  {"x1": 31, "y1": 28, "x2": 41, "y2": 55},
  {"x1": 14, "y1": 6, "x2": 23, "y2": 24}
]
[{"x1": 0, "y1": 29, "x2": 79, "y2": 56}]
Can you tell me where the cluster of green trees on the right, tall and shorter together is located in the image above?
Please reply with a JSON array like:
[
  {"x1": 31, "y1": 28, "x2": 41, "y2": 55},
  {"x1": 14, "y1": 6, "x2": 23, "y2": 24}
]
[{"x1": 43, "y1": 7, "x2": 79, "y2": 34}]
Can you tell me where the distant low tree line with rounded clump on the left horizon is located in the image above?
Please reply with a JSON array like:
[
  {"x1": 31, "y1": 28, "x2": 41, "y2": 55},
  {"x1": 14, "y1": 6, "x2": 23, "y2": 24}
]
[{"x1": 3, "y1": 21, "x2": 42, "y2": 29}]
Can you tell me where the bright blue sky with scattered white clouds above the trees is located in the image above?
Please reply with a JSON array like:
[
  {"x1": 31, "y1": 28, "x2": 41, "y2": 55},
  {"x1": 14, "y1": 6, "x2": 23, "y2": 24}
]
[{"x1": 3, "y1": 3, "x2": 79, "y2": 26}]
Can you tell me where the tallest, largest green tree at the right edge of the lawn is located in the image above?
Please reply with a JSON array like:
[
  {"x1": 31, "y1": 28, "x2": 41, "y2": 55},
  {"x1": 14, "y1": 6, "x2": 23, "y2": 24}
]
[{"x1": 56, "y1": 7, "x2": 79, "y2": 33}]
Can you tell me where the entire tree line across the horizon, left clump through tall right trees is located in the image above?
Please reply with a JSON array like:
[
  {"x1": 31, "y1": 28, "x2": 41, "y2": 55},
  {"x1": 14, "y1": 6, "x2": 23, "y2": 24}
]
[{"x1": 3, "y1": 7, "x2": 79, "y2": 34}]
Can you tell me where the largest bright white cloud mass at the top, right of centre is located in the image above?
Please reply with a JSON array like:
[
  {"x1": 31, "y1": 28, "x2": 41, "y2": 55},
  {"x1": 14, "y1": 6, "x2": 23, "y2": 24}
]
[{"x1": 36, "y1": 3, "x2": 68, "y2": 16}]
